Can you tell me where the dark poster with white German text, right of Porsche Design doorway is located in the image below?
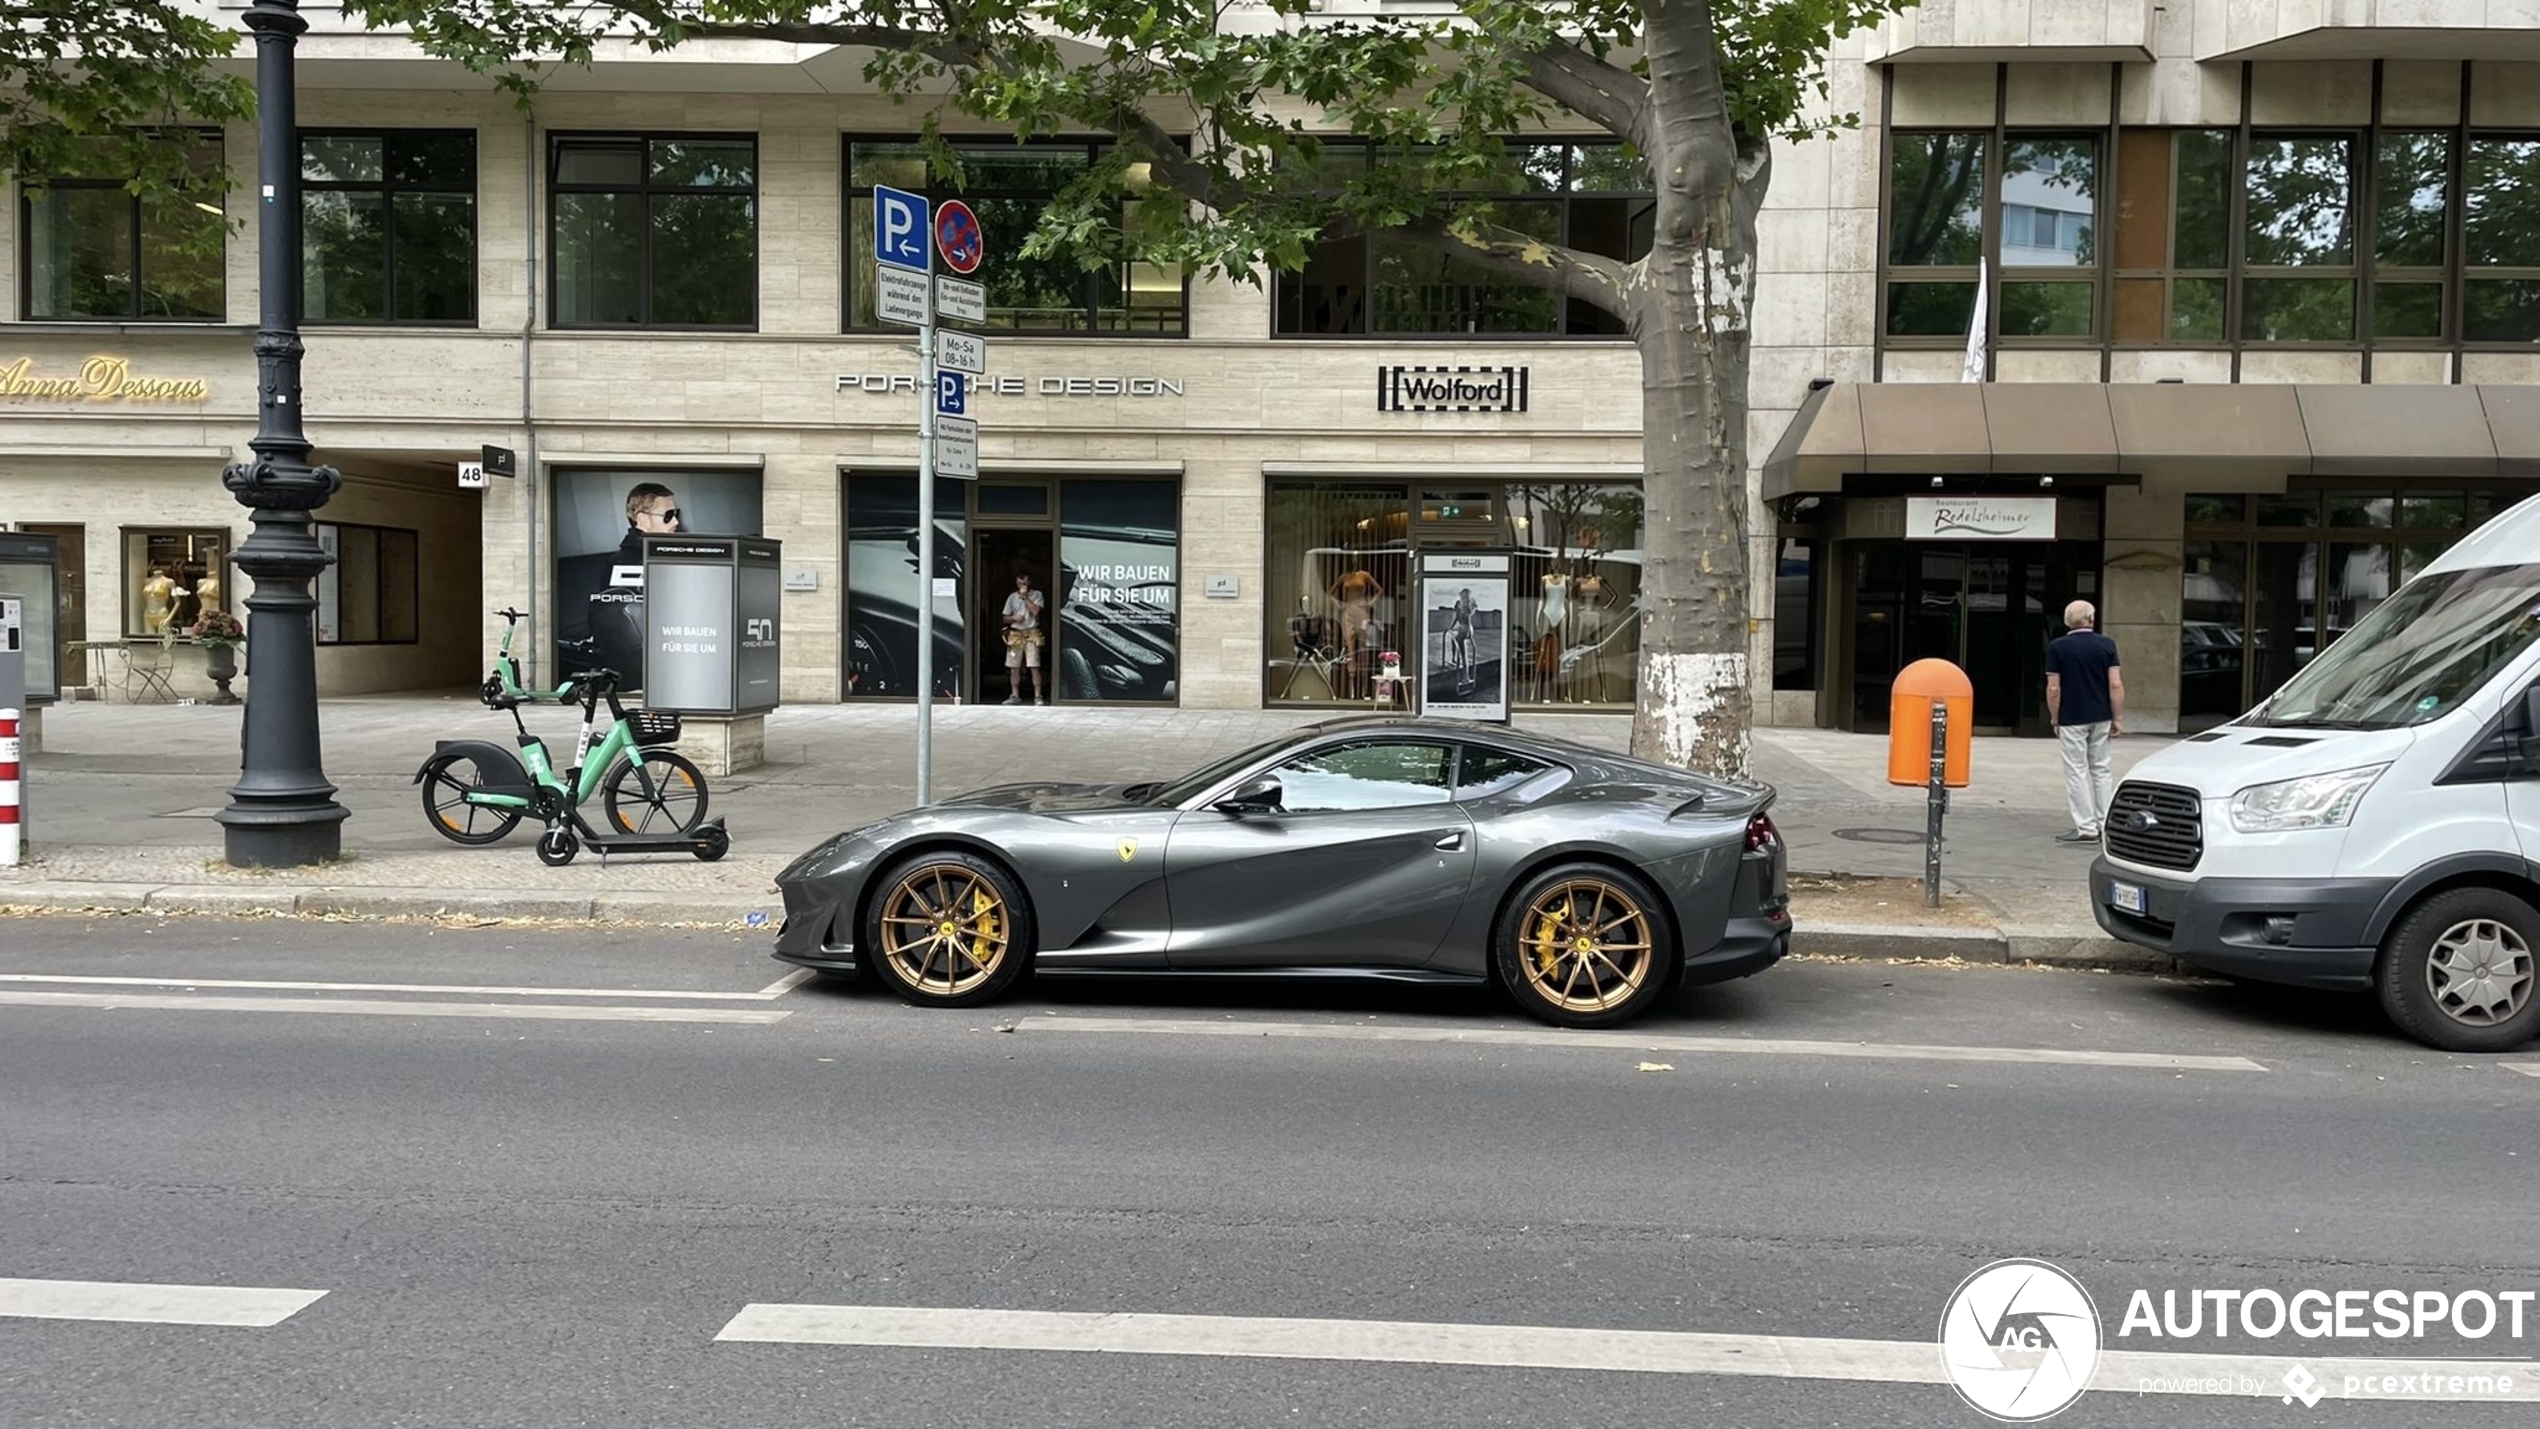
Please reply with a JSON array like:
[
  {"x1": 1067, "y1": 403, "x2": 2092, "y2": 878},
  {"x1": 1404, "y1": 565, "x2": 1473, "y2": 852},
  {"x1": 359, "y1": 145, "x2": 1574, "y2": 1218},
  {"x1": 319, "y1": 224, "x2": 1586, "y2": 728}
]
[{"x1": 1057, "y1": 480, "x2": 1181, "y2": 703}]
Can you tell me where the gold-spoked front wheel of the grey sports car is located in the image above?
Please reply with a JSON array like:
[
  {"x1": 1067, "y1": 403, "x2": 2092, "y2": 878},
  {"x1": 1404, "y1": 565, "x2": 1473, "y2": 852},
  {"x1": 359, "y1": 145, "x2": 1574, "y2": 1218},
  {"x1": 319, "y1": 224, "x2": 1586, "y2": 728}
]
[{"x1": 856, "y1": 850, "x2": 1039, "y2": 1008}]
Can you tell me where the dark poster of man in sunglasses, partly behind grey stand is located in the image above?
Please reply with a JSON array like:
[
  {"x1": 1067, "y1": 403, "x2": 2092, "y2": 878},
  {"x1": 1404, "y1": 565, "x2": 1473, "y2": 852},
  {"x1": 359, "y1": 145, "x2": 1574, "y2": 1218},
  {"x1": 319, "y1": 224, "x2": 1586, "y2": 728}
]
[{"x1": 556, "y1": 467, "x2": 762, "y2": 690}]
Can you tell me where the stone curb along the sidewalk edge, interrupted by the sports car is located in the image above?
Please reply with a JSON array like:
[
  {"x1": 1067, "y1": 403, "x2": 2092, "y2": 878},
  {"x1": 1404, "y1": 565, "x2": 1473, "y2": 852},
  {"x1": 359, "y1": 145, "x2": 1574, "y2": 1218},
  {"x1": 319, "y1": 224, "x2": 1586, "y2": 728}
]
[{"x1": 0, "y1": 881, "x2": 2189, "y2": 972}]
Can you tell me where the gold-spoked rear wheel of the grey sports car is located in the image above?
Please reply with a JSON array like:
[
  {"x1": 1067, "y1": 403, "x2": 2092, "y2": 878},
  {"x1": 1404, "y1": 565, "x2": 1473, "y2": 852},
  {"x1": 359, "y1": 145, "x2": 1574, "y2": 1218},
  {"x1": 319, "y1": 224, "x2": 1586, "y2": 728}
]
[{"x1": 1491, "y1": 863, "x2": 1681, "y2": 1028}]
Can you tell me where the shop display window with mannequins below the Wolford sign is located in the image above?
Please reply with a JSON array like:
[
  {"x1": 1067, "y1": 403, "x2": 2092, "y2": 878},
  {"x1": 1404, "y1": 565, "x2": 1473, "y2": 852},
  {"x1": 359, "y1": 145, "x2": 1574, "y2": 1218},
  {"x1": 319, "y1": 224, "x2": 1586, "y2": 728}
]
[{"x1": 1262, "y1": 482, "x2": 1643, "y2": 706}]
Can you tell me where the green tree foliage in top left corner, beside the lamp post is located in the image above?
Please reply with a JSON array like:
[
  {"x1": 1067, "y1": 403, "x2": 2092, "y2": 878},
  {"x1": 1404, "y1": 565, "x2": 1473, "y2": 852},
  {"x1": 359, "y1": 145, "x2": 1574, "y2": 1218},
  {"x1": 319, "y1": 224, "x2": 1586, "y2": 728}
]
[{"x1": 0, "y1": 0, "x2": 257, "y2": 203}]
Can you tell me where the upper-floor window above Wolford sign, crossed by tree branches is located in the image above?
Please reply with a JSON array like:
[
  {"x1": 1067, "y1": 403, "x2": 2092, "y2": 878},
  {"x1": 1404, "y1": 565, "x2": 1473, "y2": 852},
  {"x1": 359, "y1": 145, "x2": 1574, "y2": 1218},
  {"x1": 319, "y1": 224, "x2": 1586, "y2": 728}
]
[{"x1": 1275, "y1": 142, "x2": 1656, "y2": 338}]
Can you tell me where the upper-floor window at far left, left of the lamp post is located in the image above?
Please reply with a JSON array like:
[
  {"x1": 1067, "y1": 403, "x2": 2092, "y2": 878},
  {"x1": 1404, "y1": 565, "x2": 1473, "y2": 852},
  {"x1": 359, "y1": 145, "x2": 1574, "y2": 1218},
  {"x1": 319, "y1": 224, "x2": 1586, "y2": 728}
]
[{"x1": 18, "y1": 135, "x2": 229, "y2": 322}]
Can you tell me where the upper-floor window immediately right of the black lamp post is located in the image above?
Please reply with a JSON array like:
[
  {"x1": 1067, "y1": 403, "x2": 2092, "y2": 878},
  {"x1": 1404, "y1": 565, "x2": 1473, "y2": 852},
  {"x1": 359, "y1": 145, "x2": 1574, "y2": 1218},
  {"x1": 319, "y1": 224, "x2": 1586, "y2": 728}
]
[{"x1": 300, "y1": 129, "x2": 478, "y2": 322}]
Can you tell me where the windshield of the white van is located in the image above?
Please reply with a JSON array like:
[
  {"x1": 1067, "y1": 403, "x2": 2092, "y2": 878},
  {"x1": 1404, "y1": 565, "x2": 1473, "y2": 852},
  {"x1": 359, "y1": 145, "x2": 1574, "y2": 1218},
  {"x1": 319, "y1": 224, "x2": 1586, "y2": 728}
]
[{"x1": 2248, "y1": 566, "x2": 2540, "y2": 728}]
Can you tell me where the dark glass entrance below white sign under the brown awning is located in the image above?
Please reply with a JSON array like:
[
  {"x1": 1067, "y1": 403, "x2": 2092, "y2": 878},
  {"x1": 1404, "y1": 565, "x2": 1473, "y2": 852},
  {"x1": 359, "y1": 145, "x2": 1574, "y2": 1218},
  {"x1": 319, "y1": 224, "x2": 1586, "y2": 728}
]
[{"x1": 1847, "y1": 541, "x2": 2080, "y2": 736}]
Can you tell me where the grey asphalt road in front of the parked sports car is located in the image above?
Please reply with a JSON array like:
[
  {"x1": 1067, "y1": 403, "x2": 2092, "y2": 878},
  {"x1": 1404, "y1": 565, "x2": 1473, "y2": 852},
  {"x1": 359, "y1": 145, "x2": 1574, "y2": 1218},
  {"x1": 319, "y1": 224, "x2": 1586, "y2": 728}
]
[{"x1": 0, "y1": 916, "x2": 2540, "y2": 1429}]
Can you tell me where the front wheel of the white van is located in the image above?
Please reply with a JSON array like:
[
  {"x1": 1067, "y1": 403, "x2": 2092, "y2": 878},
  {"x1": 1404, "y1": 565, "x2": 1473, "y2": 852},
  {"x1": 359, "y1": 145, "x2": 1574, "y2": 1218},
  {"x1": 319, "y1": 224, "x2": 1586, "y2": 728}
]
[{"x1": 2372, "y1": 888, "x2": 2540, "y2": 1051}]
